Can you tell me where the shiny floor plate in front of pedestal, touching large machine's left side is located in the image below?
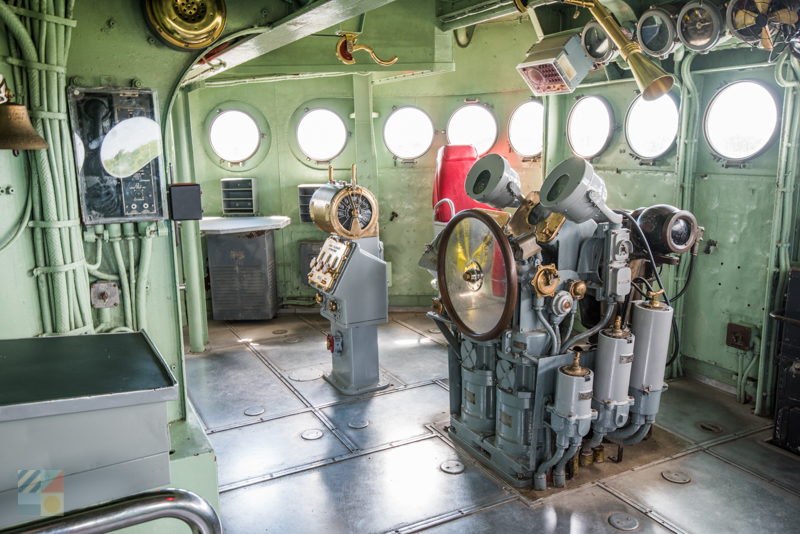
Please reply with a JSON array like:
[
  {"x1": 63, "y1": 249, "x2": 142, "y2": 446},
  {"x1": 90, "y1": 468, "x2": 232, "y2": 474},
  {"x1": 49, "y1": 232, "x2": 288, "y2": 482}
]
[{"x1": 322, "y1": 384, "x2": 449, "y2": 449}]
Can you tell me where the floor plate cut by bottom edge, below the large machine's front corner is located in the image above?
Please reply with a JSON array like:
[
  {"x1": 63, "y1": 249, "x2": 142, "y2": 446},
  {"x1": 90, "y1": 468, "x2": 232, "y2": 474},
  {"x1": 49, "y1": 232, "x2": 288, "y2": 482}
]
[{"x1": 425, "y1": 487, "x2": 671, "y2": 534}]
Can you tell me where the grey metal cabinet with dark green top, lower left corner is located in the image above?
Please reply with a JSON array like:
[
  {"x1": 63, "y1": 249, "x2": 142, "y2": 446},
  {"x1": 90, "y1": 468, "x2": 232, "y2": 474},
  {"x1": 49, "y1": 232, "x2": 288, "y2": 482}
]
[{"x1": 0, "y1": 332, "x2": 178, "y2": 529}]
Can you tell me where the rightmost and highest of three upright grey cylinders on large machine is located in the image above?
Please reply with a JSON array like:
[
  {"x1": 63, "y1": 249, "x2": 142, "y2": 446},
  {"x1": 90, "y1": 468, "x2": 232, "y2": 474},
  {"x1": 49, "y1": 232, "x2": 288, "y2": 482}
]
[{"x1": 631, "y1": 300, "x2": 672, "y2": 392}]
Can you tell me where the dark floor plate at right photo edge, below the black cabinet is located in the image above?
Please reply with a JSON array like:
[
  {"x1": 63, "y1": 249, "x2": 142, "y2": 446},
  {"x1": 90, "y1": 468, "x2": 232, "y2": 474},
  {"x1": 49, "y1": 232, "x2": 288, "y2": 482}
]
[{"x1": 711, "y1": 430, "x2": 800, "y2": 494}]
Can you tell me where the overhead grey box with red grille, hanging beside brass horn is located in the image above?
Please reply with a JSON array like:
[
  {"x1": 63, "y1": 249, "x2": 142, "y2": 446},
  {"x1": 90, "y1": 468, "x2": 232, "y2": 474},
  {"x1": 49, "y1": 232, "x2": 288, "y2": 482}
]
[{"x1": 517, "y1": 34, "x2": 592, "y2": 96}]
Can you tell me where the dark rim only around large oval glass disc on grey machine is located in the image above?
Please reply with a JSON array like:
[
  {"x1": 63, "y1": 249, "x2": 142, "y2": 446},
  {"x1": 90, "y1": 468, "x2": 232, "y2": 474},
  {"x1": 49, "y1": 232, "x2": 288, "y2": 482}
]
[{"x1": 436, "y1": 209, "x2": 519, "y2": 341}]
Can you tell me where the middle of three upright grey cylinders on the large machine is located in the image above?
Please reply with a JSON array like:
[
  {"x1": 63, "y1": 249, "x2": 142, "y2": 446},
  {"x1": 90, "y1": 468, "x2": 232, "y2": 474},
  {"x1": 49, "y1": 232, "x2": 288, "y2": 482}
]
[{"x1": 594, "y1": 330, "x2": 634, "y2": 404}]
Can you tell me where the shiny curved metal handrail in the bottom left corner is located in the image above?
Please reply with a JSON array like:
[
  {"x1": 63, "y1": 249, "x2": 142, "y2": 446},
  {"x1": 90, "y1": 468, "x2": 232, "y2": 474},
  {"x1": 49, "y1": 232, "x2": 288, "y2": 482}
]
[{"x1": 2, "y1": 488, "x2": 222, "y2": 534}]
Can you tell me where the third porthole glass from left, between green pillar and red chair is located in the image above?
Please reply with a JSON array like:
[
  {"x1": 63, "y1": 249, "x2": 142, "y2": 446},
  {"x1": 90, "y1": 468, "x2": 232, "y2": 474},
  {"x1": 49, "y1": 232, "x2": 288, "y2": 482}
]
[{"x1": 383, "y1": 106, "x2": 434, "y2": 160}]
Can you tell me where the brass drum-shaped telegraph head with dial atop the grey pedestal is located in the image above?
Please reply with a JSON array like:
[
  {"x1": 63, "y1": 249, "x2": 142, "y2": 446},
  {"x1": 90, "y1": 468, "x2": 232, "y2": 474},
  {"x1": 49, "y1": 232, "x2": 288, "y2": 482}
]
[{"x1": 309, "y1": 182, "x2": 378, "y2": 239}]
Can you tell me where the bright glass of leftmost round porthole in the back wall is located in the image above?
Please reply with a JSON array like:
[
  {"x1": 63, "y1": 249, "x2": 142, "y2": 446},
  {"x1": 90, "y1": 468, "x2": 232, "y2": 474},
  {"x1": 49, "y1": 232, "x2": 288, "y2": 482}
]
[{"x1": 208, "y1": 109, "x2": 261, "y2": 163}]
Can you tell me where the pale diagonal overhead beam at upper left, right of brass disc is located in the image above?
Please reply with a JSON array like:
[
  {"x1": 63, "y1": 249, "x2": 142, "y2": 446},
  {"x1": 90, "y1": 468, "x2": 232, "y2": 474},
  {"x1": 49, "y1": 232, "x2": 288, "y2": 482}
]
[{"x1": 181, "y1": 0, "x2": 401, "y2": 86}]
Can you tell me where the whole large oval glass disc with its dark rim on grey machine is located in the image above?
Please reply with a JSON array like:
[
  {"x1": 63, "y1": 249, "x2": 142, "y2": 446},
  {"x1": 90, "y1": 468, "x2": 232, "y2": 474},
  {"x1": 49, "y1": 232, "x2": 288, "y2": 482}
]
[{"x1": 438, "y1": 210, "x2": 518, "y2": 341}]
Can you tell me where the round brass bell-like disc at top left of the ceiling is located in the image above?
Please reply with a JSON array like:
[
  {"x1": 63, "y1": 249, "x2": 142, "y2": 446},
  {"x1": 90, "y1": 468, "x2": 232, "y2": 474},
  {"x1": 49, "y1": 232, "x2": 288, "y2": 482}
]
[{"x1": 144, "y1": 0, "x2": 227, "y2": 50}]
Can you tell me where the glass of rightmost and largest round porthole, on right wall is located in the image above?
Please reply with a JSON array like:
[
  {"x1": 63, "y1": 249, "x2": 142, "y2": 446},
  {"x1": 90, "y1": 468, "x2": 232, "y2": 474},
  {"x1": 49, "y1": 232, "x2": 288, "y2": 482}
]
[{"x1": 704, "y1": 81, "x2": 778, "y2": 161}]
